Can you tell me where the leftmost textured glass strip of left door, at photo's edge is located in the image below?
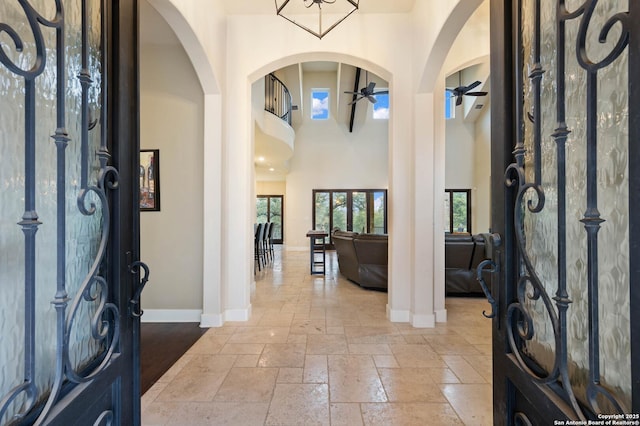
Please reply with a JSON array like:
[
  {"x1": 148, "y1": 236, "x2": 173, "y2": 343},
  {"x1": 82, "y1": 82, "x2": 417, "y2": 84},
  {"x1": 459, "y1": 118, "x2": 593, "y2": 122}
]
[{"x1": 0, "y1": 2, "x2": 28, "y2": 418}]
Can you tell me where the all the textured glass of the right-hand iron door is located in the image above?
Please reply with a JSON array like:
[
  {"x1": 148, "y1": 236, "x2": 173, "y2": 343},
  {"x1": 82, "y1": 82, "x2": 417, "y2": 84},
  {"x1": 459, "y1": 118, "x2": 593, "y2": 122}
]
[{"x1": 522, "y1": 0, "x2": 631, "y2": 406}]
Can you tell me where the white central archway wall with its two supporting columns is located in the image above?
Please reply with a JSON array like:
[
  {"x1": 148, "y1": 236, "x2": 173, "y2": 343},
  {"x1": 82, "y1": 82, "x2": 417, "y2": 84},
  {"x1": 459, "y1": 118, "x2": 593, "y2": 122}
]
[{"x1": 152, "y1": 0, "x2": 488, "y2": 327}]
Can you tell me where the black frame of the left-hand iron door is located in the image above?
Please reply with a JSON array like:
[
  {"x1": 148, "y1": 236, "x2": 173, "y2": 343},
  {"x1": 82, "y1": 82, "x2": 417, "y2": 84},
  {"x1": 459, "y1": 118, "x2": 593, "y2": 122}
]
[{"x1": 0, "y1": 0, "x2": 141, "y2": 426}]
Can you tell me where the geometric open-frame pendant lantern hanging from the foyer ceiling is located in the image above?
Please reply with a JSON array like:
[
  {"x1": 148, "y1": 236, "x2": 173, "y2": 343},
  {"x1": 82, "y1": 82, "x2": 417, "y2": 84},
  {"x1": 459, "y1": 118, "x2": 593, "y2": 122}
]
[{"x1": 275, "y1": 0, "x2": 360, "y2": 39}]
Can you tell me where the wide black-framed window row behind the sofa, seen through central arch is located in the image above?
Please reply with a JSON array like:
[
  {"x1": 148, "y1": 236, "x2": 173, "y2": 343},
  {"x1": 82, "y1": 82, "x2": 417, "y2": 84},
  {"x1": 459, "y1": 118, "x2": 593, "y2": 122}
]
[{"x1": 313, "y1": 189, "x2": 387, "y2": 246}]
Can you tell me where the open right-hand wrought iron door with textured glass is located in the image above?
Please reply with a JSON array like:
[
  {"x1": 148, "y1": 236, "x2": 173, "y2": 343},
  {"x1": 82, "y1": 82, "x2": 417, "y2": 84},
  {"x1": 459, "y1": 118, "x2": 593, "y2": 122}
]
[{"x1": 491, "y1": 0, "x2": 640, "y2": 425}]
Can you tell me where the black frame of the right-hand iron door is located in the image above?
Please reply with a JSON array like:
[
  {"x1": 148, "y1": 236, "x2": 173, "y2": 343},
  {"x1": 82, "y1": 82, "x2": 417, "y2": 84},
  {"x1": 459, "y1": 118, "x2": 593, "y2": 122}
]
[{"x1": 490, "y1": 0, "x2": 640, "y2": 425}]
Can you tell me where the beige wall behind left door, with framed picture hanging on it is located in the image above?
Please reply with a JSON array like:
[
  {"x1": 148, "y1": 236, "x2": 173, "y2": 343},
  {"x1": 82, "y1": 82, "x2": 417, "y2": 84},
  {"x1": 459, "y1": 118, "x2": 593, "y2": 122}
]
[{"x1": 140, "y1": 45, "x2": 204, "y2": 314}]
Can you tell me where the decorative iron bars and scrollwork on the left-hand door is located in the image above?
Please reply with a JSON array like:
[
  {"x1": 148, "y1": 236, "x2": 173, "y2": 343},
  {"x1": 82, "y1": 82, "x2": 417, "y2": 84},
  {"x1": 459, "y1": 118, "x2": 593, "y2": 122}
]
[{"x1": 0, "y1": 0, "x2": 120, "y2": 424}]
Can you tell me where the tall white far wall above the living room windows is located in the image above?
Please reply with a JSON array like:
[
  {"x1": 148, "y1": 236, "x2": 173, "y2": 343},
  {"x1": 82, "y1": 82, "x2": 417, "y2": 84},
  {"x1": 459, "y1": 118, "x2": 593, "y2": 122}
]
[{"x1": 285, "y1": 72, "x2": 389, "y2": 250}]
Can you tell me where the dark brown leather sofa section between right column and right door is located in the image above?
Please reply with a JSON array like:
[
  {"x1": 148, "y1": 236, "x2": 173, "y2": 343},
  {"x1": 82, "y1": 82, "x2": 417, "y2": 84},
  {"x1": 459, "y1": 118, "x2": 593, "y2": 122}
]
[{"x1": 444, "y1": 234, "x2": 487, "y2": 295}]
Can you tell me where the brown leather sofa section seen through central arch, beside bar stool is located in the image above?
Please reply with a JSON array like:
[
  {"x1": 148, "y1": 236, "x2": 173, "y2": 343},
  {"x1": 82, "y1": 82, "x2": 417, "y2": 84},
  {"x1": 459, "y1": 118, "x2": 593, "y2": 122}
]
[{"x1": 331, "y1": 231, "x2": 389, "y2": 291}]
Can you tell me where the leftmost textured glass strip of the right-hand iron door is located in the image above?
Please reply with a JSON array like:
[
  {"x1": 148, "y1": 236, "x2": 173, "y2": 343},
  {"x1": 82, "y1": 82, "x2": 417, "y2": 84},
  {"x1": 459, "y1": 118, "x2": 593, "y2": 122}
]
[{"x1": 522, "y1": 0, "x2": 558, "y2": 370}]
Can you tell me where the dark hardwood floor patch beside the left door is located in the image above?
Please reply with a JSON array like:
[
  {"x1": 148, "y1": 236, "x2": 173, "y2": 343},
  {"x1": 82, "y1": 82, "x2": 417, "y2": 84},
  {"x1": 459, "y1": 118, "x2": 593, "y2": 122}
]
[{"x1": 140, "y1": 323, "x2": 207, "y2": 394}]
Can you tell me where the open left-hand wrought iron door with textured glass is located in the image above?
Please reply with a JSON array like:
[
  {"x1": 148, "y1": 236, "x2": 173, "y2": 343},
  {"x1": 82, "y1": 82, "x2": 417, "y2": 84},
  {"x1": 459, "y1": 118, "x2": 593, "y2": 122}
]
[{"x1": 0, "y1": 0, "x2": 140, "y2": 425}]
